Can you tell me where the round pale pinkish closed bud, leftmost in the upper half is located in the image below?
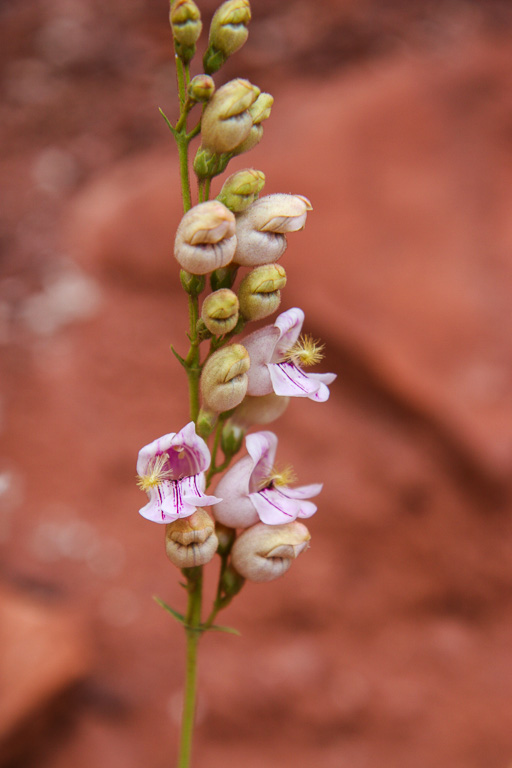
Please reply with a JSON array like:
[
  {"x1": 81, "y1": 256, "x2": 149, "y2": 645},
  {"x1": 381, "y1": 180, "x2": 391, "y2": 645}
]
[{"x1": 174, "y1": 200, "x2": 236, "y2": 275}]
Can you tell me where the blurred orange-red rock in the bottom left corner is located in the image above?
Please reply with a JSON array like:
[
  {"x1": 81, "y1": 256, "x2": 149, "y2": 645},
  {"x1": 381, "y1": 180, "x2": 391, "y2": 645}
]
[{"x1": 0, "y1": 587, "x2": 91, "y2": 766}]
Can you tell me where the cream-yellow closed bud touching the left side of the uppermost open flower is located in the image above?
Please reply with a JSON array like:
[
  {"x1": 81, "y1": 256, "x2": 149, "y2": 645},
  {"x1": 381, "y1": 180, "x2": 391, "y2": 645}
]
[{"x1": 200, "y1": 344, "x2": 250, "y2": 413}]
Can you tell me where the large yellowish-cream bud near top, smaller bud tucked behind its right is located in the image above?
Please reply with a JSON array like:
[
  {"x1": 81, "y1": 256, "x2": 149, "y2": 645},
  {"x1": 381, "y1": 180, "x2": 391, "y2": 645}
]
[{"x1": 201, "y1": 78, "x2": 260, "y2": 155}]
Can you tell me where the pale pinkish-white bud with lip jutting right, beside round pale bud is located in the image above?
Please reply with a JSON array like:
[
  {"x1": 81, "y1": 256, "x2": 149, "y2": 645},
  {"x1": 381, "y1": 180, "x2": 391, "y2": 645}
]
[{"x1": 233, "y1": 194, "x2": 313, "y2": 267}]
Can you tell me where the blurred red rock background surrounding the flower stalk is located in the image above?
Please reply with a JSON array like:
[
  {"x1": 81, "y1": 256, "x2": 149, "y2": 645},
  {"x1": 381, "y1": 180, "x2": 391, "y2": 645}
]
[{"x1": 0, "y1": 0, "x2": 512, "y2": 768}]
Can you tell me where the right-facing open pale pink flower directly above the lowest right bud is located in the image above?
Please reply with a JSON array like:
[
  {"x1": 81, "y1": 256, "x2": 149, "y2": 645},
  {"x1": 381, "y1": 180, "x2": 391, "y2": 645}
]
[{"x1": 213, "y1": 432, "x2": 322, "y2": 528}]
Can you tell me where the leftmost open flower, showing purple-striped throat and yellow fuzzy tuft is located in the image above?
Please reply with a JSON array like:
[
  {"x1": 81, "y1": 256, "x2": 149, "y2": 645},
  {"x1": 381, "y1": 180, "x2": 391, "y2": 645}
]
[{"x1": 137, "y1": 421, "x2": 220, "y2": 523}]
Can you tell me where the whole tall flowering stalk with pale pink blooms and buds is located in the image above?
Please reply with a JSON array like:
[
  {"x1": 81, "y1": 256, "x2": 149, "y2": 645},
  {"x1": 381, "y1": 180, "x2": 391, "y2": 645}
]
[{"x1": 137, "y1": 0, "x2": 335, "y2": 768}]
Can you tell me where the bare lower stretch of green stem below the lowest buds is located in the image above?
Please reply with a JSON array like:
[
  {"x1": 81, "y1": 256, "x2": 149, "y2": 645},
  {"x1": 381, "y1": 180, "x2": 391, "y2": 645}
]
[{"x1": 178, "y1": 566, "x2": 203, "y2": 768}]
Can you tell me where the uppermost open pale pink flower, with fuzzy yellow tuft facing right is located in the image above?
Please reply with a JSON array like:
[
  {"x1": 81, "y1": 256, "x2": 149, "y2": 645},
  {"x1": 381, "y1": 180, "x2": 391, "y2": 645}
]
[{"x1": 243, "y1": 307, "x2": 336, "y2": 403}]
